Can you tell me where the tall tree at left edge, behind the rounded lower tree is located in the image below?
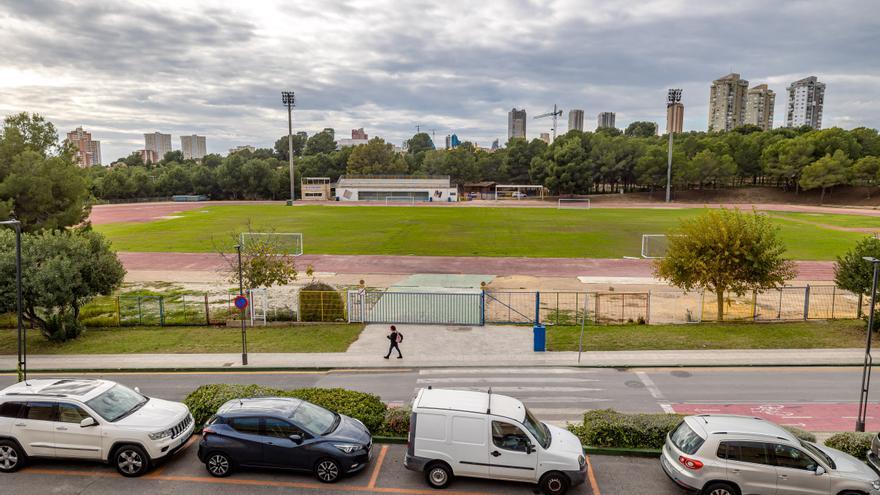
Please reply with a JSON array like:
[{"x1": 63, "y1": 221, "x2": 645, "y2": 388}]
[{"x1": 0, "y1": 114, "x2": 89, "y2": 232}]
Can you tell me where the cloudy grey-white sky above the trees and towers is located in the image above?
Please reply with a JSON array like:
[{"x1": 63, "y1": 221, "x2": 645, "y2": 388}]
[{"x1": 0, "y1": 0, "x2": 880, "y2": 164}]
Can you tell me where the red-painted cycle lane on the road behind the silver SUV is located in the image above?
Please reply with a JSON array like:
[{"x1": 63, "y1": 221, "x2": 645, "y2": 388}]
[{"x1": 672, "y1": 403, "x2": 880, "y2": 431}]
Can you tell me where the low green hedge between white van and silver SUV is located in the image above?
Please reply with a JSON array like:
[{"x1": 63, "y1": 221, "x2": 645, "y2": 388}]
[{"x1": 568, "y1": 409, "x2": 684, "y2": 449}]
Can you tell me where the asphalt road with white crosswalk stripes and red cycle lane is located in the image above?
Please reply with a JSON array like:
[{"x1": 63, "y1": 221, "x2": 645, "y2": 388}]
[{"x1": 0, "y1": 367, "x2": 880, "y2": 431}]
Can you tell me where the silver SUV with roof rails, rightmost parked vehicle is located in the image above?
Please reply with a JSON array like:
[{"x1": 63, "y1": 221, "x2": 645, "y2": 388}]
[{"x1": 660, "y1": 414, "x2": 880, "y2": 495}]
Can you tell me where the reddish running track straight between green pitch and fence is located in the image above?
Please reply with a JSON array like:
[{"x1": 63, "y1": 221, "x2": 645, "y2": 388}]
[{"x1": 119, "y1": 252, "x2": 834, "y2": 281}]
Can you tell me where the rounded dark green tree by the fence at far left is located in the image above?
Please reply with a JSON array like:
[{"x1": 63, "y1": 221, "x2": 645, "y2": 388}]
[{"x1": 0, "y1": 229, "x2": 125, "y2": 341}]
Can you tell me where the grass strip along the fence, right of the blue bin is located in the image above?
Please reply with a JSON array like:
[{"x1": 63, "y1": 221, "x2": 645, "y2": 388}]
[{"x1": 547, "y1": 320, "x2": 866, "y2": 351}]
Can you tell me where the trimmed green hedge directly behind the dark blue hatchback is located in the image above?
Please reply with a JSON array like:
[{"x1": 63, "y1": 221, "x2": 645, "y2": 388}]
[{"x1": 183, "y1": 383, "x2": 387, "y2": 432}]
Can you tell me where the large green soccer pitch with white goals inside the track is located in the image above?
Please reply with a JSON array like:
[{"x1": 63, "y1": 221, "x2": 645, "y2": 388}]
[{"x1": 94, "y1": 205, "x2": 878, "y2": 260}]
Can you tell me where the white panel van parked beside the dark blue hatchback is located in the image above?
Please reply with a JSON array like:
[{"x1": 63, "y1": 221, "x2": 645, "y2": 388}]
[{"x1": 404, "y1": 389, "x2": 586, "y2": 495}]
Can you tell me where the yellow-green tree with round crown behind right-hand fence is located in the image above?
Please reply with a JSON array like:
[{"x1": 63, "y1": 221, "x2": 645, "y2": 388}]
[{"x1": 654, "y1": 209, "x2": 795, "y2": 321}]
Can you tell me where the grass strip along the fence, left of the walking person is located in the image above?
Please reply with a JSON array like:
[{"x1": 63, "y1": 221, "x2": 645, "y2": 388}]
[{"x1": 0, "y1": 324, "x2": 363, "y2": 354}]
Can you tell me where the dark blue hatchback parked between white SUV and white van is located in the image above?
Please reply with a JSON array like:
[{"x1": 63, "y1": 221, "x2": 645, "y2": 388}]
[{"x1": 199, "y1": 398, "x2": 373, "y2": 483}]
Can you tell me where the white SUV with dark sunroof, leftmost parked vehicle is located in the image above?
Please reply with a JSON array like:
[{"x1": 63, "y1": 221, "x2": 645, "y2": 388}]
[{"x1": 0, "y1": 378, "x2": 194, "y2": 477}]
